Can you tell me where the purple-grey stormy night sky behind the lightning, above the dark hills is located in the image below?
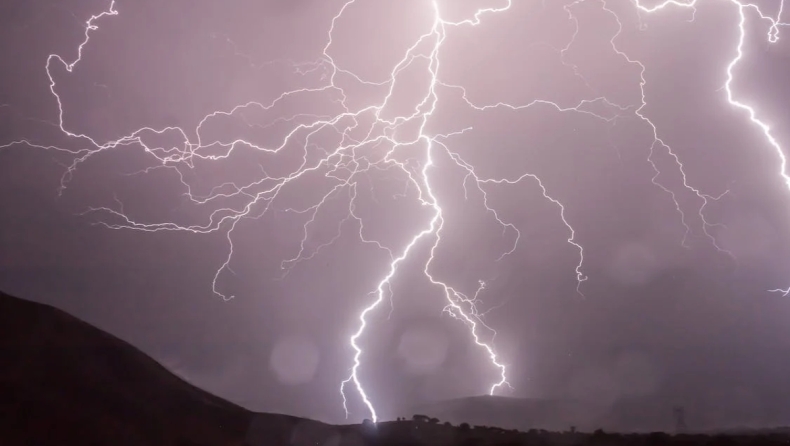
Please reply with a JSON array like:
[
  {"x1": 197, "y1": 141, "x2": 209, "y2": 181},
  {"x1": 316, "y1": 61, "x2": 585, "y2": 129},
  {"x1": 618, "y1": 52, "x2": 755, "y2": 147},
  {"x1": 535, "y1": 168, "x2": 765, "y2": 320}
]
[{"x1": 0, "y1": 0, "x2": 790, "y2": 432}]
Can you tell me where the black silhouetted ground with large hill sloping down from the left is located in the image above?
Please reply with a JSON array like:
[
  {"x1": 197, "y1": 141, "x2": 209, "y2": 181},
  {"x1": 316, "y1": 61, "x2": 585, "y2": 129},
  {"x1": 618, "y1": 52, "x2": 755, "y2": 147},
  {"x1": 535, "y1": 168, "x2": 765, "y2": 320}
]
[{"x1": 0, "y1": 293, "x2": 790, "y2": 446}]
